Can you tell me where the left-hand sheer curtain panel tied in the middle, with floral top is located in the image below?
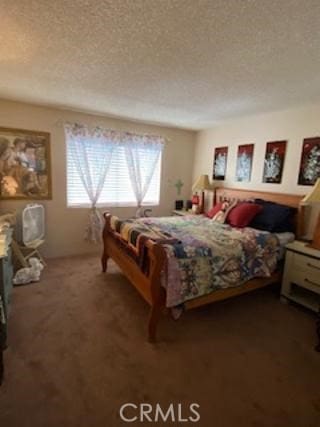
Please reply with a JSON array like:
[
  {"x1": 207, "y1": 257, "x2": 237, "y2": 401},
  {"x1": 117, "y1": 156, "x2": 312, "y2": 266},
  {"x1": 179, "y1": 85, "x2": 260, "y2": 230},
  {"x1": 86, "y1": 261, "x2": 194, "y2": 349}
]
[{"x1": 65, "y1": 124, "x2": 117, "y2": 243}]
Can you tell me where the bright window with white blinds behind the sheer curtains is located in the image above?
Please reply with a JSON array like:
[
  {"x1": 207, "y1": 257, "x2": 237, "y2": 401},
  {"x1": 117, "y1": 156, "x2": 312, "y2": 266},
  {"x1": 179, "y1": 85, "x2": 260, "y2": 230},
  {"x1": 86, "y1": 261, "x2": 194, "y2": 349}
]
[{"x1": 66, "y1": 138, "x2": 161, "y2": 207}]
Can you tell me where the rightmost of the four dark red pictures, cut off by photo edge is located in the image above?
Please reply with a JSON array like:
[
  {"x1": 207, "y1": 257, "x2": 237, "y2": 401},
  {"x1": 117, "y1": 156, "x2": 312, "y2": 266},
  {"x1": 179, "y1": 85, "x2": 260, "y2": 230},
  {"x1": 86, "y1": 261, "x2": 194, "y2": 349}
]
[{"x1": 298, "y1": 136, "x2": 320, "y2": 185}]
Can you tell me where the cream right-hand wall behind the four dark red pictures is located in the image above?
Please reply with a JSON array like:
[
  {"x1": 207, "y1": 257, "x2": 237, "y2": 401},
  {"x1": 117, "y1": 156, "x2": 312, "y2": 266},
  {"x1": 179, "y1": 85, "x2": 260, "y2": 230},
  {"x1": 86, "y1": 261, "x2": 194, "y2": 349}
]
[{"x1": 193, "y1": 104, "x2": 320, "y2": 237}]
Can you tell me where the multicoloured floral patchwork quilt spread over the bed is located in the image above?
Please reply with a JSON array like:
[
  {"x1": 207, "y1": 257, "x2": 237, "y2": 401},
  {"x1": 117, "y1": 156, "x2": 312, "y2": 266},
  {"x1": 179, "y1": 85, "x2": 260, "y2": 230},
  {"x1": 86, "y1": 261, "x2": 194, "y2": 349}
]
[{"x1": 110, "y1": 215, "x2": 280, "y2": 307}]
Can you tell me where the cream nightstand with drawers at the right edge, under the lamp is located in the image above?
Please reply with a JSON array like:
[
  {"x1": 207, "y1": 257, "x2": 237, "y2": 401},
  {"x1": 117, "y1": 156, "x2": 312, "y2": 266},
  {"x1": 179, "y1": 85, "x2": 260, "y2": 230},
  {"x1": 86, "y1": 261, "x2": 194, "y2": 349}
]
[{"x1": 281, "y1": 240, "x2": 320, "y2": 312}]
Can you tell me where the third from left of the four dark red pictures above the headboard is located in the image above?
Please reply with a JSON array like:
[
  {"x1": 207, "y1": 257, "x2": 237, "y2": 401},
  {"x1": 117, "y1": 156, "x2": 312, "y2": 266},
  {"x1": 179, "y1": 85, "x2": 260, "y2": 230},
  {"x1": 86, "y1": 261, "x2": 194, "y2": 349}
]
[{"x1": 262, "y1": 141, "x2": 287, "y2": 184}]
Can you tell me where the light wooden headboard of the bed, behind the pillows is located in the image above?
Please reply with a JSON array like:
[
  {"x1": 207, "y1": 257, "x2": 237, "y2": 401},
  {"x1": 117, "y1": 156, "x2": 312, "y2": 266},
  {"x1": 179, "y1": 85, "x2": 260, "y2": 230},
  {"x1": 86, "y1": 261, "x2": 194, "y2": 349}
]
[{"x1": 214, "y1": 187, "x2": 304, "y2": 237}]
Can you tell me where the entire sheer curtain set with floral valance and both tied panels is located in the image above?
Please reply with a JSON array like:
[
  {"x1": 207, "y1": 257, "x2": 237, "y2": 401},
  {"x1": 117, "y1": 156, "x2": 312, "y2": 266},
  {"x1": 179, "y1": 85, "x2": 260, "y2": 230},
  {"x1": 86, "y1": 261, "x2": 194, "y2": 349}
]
[{"x1": 64, "y1": 123, "x2": 165, "y2": 242}]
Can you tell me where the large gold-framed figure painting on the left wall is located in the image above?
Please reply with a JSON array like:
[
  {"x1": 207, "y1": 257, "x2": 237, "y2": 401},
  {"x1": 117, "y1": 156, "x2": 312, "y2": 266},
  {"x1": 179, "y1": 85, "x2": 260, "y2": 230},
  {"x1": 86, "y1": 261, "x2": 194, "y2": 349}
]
[{"x1": 0, "y1": 127, "x2": 52, "y2": 200}]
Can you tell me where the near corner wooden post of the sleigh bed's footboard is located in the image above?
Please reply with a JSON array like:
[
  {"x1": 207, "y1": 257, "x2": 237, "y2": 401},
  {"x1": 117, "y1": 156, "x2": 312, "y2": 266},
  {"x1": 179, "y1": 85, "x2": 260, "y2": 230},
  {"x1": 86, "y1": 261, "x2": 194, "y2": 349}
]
[{"x1": 148, "y1": 242, "x2": 167, "y2": 343}]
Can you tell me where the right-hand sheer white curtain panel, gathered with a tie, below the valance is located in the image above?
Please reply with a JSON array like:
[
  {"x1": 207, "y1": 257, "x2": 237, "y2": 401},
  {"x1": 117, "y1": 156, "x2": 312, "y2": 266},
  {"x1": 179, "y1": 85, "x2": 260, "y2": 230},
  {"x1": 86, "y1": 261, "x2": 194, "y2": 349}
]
[{"x1": 124, "y1": 136, "x2": 164, "y2": 216}]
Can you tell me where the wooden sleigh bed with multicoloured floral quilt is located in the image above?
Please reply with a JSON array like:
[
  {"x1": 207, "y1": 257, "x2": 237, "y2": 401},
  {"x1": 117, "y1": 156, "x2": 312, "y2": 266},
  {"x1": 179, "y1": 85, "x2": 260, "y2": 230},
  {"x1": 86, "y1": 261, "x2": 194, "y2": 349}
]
[{"x1": 101, "y1": 188, "x2": 302, "y2": 342}]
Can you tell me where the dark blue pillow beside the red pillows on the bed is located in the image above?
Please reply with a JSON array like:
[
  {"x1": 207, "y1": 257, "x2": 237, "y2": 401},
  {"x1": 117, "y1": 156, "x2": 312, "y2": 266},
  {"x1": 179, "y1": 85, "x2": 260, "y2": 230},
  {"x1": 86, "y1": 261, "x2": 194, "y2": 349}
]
[{"x1": 249, "y1": 199, "x2": 296, "y2": 233}]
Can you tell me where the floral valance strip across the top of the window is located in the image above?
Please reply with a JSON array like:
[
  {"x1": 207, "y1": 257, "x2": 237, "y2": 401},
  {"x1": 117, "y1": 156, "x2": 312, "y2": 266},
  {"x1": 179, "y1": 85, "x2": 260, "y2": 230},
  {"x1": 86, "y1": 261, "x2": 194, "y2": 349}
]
[{"x1": 64, "y1": 123, "x2": 166, "y2": 145}]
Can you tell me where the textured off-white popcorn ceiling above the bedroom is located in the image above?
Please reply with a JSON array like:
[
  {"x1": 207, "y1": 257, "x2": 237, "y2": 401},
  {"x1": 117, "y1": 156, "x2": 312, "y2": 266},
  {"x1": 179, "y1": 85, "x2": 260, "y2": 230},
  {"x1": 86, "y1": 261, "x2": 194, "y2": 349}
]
[{"x1": 0, "y1": 0, "x2": 320, "y2": 129}]
